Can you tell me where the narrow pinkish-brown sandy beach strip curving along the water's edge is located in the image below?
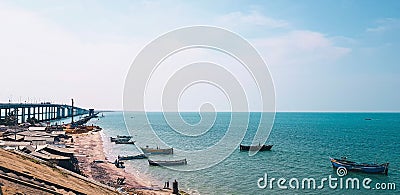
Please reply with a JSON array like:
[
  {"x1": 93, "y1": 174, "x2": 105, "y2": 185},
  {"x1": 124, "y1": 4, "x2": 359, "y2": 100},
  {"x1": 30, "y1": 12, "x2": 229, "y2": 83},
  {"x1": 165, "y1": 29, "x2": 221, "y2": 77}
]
[{"x1": 71, "y1": 132, "x2": 172, "y2": 194}]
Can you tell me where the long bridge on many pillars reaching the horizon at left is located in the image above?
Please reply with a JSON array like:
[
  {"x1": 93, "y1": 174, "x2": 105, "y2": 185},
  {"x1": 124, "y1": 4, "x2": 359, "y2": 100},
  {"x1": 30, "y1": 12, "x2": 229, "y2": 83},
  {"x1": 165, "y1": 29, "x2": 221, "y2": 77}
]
[{"x1": 0, "y1": 103, "x2": 89, "y2": 123}]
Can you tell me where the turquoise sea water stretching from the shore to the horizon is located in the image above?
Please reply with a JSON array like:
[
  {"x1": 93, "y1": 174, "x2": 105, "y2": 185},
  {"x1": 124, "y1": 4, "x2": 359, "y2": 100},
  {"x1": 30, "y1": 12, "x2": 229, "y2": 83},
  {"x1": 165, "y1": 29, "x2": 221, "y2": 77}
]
[{"x1": 91, "y1": 112, "x2": 400, "y2": 194}]
